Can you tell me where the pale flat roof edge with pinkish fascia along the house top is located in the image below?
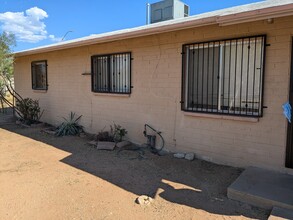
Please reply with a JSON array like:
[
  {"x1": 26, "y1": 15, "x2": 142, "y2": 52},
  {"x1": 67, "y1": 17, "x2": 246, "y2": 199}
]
[{"x1": 14, "y1": 0, "x2": 293, "y2": 57}]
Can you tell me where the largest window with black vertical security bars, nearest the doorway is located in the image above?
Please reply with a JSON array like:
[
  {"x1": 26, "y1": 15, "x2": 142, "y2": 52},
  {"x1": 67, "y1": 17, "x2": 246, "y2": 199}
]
[{"x1": 181, "y1": 36, "x2": 266, "y2": 117}]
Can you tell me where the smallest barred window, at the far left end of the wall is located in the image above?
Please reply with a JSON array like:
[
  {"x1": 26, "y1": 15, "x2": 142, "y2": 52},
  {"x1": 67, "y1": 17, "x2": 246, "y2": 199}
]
[{"x1": 32, "y1": 60, "x2": 48, "y2": 90}]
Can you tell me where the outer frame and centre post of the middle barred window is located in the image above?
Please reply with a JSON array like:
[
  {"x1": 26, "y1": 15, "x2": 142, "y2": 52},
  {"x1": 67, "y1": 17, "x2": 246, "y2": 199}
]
[{"x1": 91, "y1": 51, "x2": 133, "y2": 95}]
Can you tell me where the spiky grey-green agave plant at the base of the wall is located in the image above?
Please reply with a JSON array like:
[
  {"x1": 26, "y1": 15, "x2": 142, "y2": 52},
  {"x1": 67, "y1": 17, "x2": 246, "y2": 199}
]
[{"x1": 55, "y1": 112, "x2": 83, "y2": 136}]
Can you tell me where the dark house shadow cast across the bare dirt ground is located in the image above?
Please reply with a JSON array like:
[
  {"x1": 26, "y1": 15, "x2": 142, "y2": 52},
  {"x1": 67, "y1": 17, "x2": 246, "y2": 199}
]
[{"x1": 0, "y1": 121, "x2": 267, "y2": 219}]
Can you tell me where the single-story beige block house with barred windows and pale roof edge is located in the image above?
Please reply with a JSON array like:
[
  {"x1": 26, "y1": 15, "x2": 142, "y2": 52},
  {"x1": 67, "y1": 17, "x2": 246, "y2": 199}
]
[{"x1": 15, "y1": 0, "x2": 293, "y2": 173}]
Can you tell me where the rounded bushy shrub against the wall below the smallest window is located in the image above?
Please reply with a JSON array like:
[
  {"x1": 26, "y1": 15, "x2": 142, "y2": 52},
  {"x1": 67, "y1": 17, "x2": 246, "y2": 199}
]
[{"x1": 16, "y1": 98, "x2": 43, "y2": 125}]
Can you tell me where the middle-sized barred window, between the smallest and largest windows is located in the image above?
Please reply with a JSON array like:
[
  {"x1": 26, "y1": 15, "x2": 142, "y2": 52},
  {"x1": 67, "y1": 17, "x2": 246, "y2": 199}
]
[{"x1": 92, "y1": 52, "x2": 131, "y2": 94}]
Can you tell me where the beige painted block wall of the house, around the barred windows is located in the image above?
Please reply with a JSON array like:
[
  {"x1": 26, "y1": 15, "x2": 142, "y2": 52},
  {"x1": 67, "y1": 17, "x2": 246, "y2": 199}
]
[{"x1": 15, "y1": 17, "x2": 293, "y2": 172}]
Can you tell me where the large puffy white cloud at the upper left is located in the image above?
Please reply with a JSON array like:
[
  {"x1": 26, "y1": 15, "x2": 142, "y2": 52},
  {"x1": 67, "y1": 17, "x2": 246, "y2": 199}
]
[{"x1": 0, "y1": 7, "x2": 59, "y2": 43}]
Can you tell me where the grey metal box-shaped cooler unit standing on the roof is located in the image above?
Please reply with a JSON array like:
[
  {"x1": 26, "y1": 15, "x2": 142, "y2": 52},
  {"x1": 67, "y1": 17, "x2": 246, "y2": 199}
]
[{"x1": 151, "y1": 0, "x2": 189, "y2": 23}]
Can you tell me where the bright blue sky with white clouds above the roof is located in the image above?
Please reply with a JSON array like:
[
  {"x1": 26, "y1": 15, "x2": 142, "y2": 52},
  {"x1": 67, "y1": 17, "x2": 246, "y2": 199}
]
[{"x1": 0, "y1": 0, "x2": 261, "y2": 51}]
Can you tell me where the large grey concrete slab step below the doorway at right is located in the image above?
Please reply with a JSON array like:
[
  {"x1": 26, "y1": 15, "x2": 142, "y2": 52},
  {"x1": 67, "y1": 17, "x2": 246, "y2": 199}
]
[{"x1": 228, "y1": 167, "x2": 293, "y2": 210}]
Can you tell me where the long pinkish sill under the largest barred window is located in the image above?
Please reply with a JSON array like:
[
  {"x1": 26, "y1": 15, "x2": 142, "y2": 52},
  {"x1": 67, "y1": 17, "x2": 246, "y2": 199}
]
[{"x1": 184, "y1": 112, "x2": 259, "y2": 122}]
